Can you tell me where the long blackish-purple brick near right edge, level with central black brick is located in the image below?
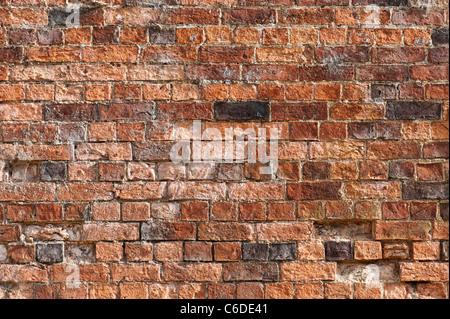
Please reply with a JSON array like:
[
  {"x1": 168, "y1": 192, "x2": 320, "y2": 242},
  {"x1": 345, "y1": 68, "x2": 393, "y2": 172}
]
[{"x1": 386, "y1": 101, "x2": 442, "y2": 120}]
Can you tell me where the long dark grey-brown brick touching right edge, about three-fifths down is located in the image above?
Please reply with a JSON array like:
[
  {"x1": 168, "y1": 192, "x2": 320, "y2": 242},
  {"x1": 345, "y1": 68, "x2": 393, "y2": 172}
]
[{"x1": 403, "y1": 182, "x2": 449, "y2": 199}]
